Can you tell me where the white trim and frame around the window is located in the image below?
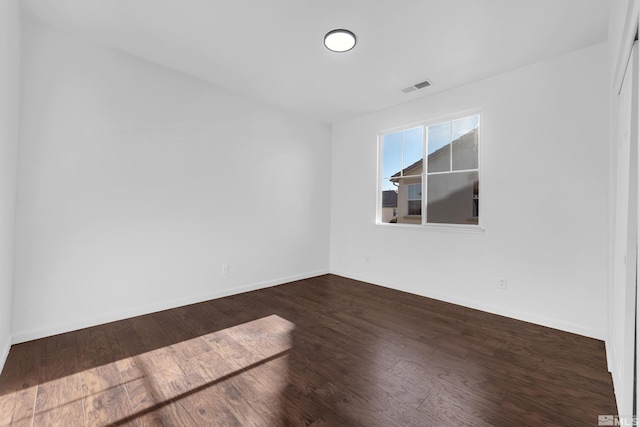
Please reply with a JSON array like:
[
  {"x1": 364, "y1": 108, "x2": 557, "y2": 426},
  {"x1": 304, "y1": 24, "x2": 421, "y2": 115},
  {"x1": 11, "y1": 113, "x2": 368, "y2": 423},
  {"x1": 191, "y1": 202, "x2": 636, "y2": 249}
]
[{"x1": 374, "y1": 109, "x2": 485, "y2": 233}]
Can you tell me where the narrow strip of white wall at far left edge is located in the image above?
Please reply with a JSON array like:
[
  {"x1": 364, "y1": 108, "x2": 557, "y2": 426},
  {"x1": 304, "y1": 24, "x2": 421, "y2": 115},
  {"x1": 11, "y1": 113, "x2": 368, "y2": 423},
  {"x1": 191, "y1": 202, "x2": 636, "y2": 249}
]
[{"x1": 0, "y1": 0, "x2": 20, "y2": 370}]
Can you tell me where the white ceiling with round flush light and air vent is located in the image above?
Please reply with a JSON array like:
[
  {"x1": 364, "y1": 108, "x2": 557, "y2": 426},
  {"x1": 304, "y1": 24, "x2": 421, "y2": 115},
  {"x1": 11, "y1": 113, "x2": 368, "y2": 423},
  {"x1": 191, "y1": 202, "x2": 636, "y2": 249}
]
[{"x1": 23, "y1": 0, "x2": 610, "y2": 122}]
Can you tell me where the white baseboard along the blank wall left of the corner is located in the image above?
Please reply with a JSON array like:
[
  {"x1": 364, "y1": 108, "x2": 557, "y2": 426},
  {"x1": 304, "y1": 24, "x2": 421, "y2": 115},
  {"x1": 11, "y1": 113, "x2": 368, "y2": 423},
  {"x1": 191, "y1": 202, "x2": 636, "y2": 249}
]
[{"x1": 7, "y1": 270, "x2": 329, "y2": 344}]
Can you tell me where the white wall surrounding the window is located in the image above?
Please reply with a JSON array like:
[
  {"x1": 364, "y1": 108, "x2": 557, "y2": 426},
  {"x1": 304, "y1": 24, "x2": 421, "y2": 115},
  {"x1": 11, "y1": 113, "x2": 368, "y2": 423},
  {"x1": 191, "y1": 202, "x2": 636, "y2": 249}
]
[{"x1": 331, "y1": 44, "x2": 609, "y2": 338}]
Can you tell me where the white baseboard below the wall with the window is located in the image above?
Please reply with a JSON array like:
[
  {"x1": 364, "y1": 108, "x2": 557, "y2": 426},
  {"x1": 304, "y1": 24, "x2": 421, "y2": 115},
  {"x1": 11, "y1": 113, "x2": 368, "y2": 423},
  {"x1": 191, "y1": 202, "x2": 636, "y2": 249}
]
[{"x1": 331, "y1": 270, "x2": 606, "y2": 341}]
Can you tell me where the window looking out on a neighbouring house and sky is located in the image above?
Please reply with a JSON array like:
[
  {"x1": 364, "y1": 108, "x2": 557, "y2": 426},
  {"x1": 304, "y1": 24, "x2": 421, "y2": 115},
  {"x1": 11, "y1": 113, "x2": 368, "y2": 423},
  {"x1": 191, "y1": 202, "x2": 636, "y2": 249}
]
[{"x1": 378, "y1": 114, "x2": 480, "y2": 225}]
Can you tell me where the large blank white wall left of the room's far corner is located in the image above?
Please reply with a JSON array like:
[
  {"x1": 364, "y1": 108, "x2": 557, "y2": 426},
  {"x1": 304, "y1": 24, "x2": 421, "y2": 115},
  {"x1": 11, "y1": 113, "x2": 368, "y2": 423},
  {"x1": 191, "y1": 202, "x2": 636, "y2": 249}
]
[{"x1": 13, "y1": 18, "x2": 331, "y2": 342}]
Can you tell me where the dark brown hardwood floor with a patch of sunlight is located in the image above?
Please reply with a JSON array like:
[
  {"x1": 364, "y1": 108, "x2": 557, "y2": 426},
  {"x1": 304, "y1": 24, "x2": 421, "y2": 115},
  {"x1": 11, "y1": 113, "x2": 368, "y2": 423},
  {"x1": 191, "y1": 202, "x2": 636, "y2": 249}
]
[{"x1": 0, "y1": 275, "x2": 617, "y2": 427}]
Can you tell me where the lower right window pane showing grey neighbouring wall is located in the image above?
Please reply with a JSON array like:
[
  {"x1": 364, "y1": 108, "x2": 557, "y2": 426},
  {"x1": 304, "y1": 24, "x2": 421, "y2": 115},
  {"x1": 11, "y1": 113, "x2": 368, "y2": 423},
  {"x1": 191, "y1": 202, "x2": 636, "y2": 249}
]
[{"x1": 427, "y1": 171, "x2": 479, "y2": 224}]
